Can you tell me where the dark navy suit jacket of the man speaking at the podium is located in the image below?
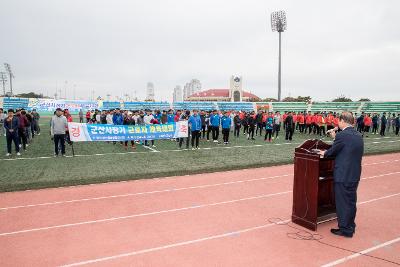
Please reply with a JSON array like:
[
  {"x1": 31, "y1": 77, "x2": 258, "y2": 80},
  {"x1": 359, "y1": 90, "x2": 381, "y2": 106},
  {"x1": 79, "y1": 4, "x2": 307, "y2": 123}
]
[{"x1": 325, "y1": 127, "x2": 364, "y2": 183}]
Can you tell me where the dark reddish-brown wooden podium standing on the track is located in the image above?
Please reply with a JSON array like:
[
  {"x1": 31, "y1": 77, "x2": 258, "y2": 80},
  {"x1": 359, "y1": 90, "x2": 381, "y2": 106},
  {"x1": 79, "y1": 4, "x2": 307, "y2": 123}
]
[{"x1": 292, "y1": 139, "x2": 336, "y2": 231}]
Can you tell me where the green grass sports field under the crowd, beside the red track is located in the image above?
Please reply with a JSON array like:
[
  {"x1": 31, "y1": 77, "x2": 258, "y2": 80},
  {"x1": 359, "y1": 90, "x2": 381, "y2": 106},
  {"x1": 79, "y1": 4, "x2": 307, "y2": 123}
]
[{"x1": 0, "y1": 118, "x2": 400, "y2": 192}]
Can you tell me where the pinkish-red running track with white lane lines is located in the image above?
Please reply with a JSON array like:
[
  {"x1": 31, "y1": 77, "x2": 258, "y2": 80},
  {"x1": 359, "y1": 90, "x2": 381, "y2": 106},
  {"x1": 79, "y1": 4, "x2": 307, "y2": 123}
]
[{"x1": 0, "y1": 153, "x2": 400, "y2": 267}]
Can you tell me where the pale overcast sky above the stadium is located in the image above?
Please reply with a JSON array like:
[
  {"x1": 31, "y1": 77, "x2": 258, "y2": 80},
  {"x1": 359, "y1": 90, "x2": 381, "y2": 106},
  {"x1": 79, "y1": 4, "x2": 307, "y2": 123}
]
[{"x1": 0, "y1": 0, "x2": 400, "y2": 101}]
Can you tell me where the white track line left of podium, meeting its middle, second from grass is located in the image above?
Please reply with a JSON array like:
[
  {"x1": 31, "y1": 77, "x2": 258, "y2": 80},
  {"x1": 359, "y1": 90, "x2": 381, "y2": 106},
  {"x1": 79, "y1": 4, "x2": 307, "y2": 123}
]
[{"x1": 0, "y1": 191, "x2": 292, "y2": 237}]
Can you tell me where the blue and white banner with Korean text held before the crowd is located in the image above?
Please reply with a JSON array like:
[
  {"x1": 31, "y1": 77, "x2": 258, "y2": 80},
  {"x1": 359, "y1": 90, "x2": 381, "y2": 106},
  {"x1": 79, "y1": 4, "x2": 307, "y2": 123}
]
[{"x1": 68, "y1": 121, "x2": 189, "y2": 142}]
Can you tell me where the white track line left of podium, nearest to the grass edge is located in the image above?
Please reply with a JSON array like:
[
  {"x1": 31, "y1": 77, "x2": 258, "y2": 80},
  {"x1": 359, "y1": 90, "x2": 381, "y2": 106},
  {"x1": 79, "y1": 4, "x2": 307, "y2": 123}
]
[{"x1": 0, "y1": 174, "x2": 291, "y2": 210}]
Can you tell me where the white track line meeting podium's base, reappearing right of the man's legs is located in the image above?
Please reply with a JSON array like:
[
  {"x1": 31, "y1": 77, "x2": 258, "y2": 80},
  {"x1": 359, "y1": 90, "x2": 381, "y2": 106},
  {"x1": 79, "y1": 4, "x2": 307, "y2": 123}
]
[{"x1": 59, "y1": 193, "x2": 400, "y2": 267}]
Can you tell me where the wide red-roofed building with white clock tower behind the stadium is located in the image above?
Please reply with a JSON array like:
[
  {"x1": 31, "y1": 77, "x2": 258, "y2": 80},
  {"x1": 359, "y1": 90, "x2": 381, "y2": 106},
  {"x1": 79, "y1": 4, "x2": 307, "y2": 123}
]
[{"x1": 185, "y1": 76, "x2": 261, "y2": 102}]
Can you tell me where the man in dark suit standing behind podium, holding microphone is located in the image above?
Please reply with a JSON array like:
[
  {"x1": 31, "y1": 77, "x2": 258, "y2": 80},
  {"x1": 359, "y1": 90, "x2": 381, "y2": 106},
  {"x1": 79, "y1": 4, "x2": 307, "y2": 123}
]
[{"x1": 320, "y1": 112, "x2": 364, "y2": 237}]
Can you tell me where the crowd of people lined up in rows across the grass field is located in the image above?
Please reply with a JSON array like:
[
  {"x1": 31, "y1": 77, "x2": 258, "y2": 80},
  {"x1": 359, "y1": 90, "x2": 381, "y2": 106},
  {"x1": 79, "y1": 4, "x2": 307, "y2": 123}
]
[{"x1": 0, "y1": 109, "x2": 400, "y2": 156}]
